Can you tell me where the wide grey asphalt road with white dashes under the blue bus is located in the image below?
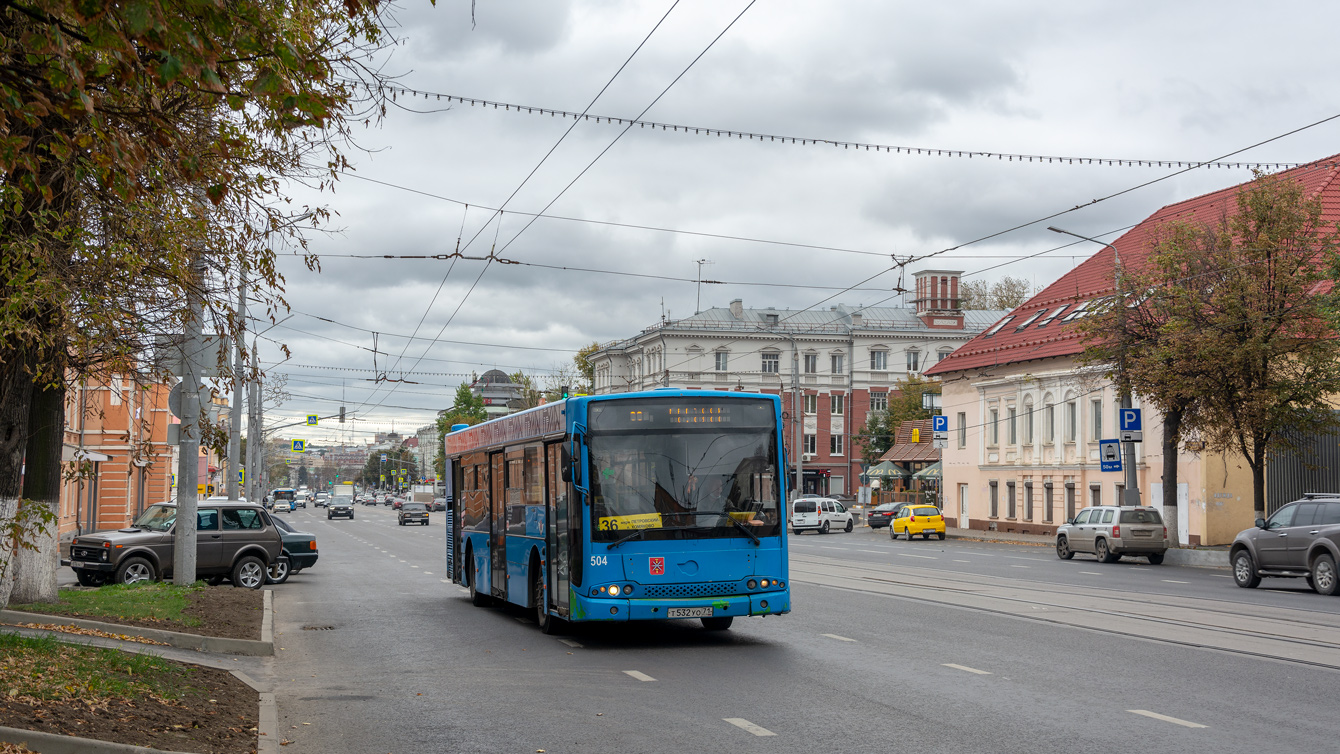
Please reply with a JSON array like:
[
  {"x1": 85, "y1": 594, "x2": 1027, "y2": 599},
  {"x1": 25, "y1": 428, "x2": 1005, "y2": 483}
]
[{"x1": 246, "y1": 506, "x2": 1340, "y2": 754}]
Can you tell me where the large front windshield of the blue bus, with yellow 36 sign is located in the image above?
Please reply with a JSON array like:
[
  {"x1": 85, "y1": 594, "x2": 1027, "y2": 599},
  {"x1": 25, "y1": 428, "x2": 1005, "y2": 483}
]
[{"x1": 587, "y1": 399, "x2": 780, "y2": 542}]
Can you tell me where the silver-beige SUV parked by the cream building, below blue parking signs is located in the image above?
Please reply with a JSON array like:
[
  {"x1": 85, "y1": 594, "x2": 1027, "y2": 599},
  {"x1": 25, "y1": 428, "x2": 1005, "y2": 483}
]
[{"x1": 1056, "y1": 505, "x2": 1171, "y2": 565}]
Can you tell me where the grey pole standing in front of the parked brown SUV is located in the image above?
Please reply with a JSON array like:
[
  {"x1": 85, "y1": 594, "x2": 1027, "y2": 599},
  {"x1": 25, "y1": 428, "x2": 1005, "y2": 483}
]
[{"x1": 172, "y1": 252, "x2": 205, "y2": 587}]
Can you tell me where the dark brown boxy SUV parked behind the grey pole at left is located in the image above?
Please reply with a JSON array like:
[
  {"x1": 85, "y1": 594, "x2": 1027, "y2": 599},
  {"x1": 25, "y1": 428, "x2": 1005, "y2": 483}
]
[{"x1": 70, "y1": 501, "x2": 284, "y2": 589}]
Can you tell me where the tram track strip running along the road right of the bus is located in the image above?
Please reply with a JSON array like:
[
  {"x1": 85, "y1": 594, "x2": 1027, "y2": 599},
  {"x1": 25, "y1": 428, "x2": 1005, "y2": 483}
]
[{"x1": 791, "y1": 553, "x2": 1340, "y2": 671}]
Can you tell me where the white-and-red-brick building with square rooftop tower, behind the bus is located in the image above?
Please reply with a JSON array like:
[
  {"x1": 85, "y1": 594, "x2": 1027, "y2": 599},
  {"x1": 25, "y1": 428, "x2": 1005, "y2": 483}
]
[{"x1": 591, "y1": 271, "x2": 1005, "y2": 496}]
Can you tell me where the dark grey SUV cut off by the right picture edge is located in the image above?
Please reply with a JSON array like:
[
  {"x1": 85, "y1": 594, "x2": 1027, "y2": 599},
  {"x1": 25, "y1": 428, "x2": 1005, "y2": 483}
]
[{"x1": 1229, "y1": 493, "x2": 1340, "y2": 595}]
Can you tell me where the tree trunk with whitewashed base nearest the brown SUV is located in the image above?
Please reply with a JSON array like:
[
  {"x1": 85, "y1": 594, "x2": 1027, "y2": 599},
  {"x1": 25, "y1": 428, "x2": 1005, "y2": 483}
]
[{"x1": 9, "y1": 380, "x2": 66, "y2": 603}]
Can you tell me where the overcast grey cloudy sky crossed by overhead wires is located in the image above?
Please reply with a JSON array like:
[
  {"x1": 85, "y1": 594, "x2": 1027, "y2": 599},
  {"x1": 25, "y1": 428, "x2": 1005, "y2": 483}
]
[{"x1": 249, "y1": 0, "x2": 1340, "y2": 441}]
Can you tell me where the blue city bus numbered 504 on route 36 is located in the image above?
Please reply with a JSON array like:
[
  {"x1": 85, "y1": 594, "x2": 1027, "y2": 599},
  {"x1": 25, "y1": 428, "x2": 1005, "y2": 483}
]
[{"x1": 444, "y1": 388, "x2": 791, "y2": 633}]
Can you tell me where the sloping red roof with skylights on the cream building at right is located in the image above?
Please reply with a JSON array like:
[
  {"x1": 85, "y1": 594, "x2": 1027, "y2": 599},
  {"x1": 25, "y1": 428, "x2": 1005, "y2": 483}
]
[{"x1": 926, "y1": 155, "x2": 1340, "y2": 376}]
